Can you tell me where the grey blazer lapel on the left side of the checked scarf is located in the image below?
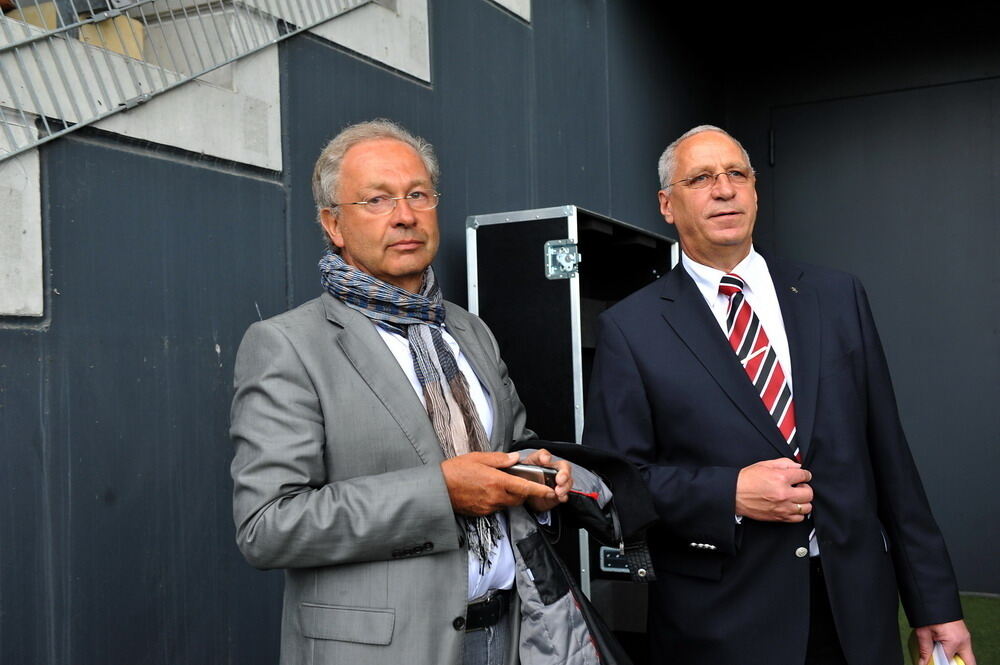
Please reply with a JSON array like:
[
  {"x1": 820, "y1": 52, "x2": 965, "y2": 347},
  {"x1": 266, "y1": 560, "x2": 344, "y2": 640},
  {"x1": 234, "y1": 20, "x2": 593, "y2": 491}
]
[{"x1": 322, "y1": 293, "x2": 444, "y2": 464}]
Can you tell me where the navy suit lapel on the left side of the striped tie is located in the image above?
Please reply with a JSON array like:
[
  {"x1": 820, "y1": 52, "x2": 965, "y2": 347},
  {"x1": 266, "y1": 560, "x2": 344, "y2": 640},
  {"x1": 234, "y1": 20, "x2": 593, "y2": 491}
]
[{"x1": 661, "y1": 265, "x2": 791, "y2": 457}]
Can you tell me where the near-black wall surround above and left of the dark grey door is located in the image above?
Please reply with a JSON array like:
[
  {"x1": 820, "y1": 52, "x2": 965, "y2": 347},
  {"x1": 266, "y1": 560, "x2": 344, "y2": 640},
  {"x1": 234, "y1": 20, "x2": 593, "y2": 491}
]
[{"x1": 720, "y1": 4, "x2": 1000, "y2": 248}]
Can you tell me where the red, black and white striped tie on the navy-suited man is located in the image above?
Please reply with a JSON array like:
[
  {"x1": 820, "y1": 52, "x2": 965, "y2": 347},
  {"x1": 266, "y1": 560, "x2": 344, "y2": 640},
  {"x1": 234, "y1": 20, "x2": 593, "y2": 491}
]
[{"x1": 719, "y1": 273, "x2": 802, "y2": 462}]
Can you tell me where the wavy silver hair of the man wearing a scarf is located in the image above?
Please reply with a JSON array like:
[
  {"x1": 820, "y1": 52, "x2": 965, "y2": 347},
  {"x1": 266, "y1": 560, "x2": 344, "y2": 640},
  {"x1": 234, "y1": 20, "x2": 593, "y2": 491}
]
[{"x1": 312, "y1": 118, "x2": 439, "y2": 228}]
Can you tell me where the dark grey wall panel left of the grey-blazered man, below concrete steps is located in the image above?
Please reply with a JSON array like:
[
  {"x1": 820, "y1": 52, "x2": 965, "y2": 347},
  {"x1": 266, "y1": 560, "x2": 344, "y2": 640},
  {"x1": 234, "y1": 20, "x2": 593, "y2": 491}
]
[{"x1": 0, "y1": 137, "x2": 285, "y2": 663}]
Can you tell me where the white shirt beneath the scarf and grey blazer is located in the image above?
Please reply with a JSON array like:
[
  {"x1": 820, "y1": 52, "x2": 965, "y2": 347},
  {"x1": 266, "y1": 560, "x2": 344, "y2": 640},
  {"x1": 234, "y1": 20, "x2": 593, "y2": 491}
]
[{"x1": 373, "y1": 324, "x2": 514, "y2": 600}]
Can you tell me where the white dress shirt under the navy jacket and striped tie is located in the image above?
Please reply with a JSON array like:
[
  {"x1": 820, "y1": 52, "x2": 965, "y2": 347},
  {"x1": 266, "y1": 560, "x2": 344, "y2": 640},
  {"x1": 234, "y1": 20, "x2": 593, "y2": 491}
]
[{"x1": 681, "y1": 245, "x2": 819, "y2": 556}]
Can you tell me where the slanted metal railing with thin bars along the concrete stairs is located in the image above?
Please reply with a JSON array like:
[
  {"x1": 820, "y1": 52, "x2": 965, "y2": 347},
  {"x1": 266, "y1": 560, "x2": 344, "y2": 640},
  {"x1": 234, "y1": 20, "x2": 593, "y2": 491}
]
[{"x1": 0, "y1": 0, "x2": 376, "y2": 161}]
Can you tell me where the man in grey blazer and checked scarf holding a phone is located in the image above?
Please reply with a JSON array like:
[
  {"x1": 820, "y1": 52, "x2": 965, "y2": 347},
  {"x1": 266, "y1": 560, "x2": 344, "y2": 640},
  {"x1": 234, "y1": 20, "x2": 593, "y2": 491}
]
[{"x1": 231, "y1": 120, "x2": 572, "y2": 665}]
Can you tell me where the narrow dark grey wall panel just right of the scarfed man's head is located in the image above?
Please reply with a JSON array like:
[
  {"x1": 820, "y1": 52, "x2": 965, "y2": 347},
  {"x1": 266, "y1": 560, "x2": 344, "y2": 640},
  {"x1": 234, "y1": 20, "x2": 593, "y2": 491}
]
[{"x1": 429, "y1": 0, "x2": 540, "y2": 294}]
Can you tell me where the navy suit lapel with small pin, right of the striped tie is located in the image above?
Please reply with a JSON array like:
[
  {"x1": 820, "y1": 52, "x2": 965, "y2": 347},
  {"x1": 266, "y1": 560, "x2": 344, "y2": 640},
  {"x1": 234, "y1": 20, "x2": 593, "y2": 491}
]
[{"x1": 765, "y1": 258, "x2": 821, "y2": 460}]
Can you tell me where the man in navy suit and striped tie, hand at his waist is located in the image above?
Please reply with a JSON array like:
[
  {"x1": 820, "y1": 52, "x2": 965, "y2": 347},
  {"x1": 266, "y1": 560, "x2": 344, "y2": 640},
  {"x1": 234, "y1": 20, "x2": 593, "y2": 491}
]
[{"x1": 584, "y1": 125, "x2": 975, "y2": 665}]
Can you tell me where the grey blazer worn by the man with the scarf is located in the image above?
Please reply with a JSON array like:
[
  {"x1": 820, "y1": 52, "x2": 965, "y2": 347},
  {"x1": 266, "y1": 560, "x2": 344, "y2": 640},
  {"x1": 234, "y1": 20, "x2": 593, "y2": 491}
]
[{"x1": 230, "y1": 294, "x2": 532, "y2": 665}]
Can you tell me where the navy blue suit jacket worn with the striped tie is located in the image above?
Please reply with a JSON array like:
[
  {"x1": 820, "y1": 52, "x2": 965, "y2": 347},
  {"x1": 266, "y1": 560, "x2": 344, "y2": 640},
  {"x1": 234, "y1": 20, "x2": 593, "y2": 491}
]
[{"x1": 584, "y1": 258, "x2": 961, "y2": 665}]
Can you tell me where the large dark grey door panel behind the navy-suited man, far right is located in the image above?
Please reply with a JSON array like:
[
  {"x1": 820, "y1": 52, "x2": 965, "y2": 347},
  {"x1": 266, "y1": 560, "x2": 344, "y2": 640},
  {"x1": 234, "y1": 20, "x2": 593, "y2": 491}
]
[{"x1": 760, "y1": 80, "x2": 1000, "y2": 593}]
